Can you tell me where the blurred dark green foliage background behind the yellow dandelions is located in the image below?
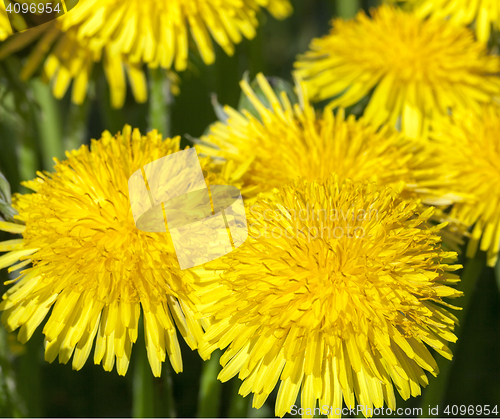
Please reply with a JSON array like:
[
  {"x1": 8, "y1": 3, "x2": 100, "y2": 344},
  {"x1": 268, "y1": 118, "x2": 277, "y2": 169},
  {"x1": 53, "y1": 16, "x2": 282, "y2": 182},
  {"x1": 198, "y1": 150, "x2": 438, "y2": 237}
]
[{"x1": 0, "y1": 0, "x2": 500, "y2": 417}]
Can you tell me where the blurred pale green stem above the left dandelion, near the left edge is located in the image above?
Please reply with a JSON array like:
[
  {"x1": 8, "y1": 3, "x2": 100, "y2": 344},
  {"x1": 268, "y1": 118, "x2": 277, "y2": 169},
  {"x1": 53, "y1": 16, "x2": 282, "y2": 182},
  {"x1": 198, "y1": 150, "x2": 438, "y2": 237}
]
[{"x1": 30, "y1": 79, "x2": 64, "y2": 170}]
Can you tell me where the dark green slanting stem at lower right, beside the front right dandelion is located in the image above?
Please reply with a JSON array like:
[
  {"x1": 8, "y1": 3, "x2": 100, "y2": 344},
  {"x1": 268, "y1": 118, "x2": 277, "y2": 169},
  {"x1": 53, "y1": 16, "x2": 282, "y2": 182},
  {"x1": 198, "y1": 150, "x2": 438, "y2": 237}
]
[{"x1": 421, "y1": 252, "x2": 486, "y2": 412}]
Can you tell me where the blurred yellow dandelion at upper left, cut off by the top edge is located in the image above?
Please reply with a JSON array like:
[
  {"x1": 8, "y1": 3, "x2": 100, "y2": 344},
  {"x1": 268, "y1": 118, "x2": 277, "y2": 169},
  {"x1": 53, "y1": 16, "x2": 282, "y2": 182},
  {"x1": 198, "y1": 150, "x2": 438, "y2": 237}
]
[{"x1": 8, "y1": 0, "x2": 291, "y2": 107}]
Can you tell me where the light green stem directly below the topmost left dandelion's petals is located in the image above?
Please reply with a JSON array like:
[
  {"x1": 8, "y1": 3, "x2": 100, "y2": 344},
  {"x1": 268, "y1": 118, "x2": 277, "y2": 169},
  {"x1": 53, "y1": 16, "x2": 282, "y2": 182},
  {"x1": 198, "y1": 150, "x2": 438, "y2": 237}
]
[{"x1": 149, "y1": 68, "x2": 172, "y2": 138}]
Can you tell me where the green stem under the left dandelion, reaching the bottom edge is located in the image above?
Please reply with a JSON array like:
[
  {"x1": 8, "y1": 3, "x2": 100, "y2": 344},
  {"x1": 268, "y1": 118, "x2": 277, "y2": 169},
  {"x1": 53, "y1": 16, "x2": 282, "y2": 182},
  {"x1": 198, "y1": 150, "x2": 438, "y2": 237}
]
[{"x1": 132, "y1": 330, "x2": 155, "y2": 418}]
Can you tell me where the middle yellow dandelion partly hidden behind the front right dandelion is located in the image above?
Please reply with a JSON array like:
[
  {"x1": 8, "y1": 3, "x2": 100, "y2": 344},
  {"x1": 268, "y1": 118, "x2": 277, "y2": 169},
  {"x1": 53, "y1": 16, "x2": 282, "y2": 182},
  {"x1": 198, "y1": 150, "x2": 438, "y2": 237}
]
[{"x1": 197, "y1": 74, "x2": 457, "y2": 204}]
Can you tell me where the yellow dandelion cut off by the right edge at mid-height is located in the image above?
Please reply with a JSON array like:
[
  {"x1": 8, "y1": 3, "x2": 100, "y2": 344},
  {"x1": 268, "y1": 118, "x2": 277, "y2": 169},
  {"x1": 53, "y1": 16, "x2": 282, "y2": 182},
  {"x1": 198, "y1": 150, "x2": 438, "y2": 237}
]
[{"x1": 431, "y1": 105, "x2": 500, "y2": 266}]
